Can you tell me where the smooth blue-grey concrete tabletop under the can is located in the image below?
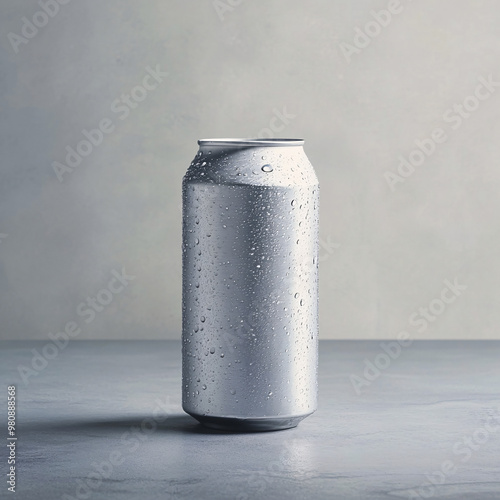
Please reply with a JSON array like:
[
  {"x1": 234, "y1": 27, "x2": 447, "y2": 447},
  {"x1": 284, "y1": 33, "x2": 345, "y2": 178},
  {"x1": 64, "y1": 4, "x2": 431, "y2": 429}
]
[{"x1": 0, "y1": 341, "x2": 500, "y2": 500}]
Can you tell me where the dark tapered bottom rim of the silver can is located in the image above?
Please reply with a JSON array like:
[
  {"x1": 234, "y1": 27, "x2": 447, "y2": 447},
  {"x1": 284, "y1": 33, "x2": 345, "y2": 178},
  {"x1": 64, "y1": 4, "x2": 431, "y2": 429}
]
[{"x1": 186, "y1": 412, "x2": 308, "y2": 432}]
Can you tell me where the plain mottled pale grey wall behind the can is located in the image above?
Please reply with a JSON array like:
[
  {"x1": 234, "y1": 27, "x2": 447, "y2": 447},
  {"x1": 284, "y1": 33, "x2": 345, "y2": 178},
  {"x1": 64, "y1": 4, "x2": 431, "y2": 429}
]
[{"x1": 0, "y1": 0, "x2": 500, "y2": 340}]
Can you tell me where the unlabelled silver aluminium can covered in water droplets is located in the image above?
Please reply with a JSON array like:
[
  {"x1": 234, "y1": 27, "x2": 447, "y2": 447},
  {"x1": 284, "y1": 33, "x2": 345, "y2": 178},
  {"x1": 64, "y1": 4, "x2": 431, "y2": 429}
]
[{"x1": 182, "y1": 139, "x2": 319, "y2": 431}]
